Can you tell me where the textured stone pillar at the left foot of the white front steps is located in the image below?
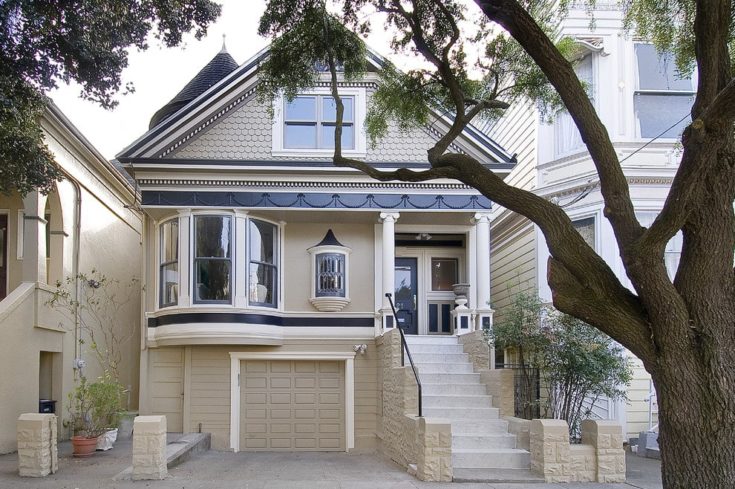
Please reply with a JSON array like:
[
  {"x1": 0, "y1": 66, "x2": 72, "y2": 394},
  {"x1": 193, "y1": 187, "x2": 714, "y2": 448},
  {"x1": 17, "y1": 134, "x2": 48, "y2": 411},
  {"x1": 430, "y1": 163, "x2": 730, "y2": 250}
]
[{"x1": 416, "y1": 418, "x2": 453, "y2": 482}]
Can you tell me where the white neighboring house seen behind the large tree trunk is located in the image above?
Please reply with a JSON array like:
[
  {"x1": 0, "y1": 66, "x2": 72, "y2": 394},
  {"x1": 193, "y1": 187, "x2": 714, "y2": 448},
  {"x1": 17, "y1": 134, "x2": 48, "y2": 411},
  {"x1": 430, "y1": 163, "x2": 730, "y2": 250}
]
[{"x1": 489, "y1": 2, "x2": 696, "y2": 436}]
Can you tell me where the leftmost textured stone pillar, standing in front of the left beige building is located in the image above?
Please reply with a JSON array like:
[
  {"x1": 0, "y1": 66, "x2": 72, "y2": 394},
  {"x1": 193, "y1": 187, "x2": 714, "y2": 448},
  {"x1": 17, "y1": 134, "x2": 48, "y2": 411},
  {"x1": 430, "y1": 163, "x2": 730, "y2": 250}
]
[{"x1": 17, "y1": 413, "x2": 59, "y2": 477}]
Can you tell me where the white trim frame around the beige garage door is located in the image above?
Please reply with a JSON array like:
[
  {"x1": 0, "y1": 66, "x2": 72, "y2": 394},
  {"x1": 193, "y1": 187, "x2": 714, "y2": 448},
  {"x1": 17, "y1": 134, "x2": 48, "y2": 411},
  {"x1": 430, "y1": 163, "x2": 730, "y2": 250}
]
[{"x1": 230, "y1": 352, "x2": 356, "y2": 452}]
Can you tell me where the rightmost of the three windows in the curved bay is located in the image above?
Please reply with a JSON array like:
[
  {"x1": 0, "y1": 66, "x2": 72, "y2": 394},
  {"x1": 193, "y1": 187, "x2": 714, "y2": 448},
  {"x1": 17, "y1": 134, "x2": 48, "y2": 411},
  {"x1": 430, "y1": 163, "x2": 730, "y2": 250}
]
[{"x1": 248, "y1": 219, "x2": 278, "y2": 307}]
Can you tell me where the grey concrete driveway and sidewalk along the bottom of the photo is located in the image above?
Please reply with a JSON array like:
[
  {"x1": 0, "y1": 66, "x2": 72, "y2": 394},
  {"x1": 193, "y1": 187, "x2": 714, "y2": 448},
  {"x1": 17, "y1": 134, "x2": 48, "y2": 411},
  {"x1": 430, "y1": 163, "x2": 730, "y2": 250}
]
[{"x1": 0, "y1": 440, "x2": 662, "y2": 489}]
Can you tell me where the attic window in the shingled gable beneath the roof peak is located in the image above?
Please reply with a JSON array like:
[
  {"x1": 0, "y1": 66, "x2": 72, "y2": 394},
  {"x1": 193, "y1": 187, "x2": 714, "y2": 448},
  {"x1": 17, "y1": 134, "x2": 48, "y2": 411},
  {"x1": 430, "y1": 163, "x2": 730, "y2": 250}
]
[{"x1": 283, "y1": 95, "x2": 355, "y2": 149}]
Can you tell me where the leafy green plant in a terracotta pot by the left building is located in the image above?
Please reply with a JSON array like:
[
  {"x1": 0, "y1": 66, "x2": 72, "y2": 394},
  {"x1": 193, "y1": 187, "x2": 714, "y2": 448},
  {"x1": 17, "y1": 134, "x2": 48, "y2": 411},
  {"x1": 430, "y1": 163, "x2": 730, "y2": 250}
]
[{"x1": 66, "y1": 375, "x2": 122, "y2": 457}]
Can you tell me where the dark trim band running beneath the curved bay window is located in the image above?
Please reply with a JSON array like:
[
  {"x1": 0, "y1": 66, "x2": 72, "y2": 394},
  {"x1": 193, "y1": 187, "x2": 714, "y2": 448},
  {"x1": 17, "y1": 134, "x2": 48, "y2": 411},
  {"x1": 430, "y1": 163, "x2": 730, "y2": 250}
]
[{"x1": 148, "y1": 312, "x2": 375, "y2": 328}]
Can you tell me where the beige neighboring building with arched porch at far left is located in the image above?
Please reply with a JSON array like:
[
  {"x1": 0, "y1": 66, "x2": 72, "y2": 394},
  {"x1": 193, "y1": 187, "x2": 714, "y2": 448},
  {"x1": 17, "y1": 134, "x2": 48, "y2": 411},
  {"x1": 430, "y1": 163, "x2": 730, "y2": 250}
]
[{"x1": 0, "y1": 103, "x2": 143, "y2": 453}]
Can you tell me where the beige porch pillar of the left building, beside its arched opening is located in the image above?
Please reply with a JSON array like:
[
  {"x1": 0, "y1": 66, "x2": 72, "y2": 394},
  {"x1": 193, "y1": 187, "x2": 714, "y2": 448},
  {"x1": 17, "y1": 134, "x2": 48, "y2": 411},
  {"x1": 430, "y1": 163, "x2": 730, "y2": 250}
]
[{"x1": 22, "y1": 191, "x2": 47, "y2": 283}]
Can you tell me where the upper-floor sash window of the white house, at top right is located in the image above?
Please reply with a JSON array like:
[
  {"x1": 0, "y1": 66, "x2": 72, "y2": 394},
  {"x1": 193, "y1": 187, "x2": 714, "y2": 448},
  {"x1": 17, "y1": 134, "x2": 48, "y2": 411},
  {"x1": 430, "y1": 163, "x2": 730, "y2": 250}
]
[{"x1": 635, "y1": 43, "x2": 694, "y2": 138}]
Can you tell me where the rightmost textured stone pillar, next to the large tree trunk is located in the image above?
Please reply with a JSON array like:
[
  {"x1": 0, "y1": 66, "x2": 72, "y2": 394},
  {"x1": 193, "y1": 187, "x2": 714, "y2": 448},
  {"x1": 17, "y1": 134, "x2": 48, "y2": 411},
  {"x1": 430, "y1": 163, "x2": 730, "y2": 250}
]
[{"x1": 582, "y1": 420, "x2": 625, "y2": 482}]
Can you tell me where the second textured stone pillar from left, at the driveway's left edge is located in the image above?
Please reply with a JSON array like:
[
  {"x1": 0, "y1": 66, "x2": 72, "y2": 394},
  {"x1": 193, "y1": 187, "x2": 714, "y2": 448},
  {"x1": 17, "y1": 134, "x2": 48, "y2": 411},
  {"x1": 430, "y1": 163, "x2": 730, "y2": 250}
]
[{"x1": 133, "y1": 416, "x2": 168, "y2": 480}]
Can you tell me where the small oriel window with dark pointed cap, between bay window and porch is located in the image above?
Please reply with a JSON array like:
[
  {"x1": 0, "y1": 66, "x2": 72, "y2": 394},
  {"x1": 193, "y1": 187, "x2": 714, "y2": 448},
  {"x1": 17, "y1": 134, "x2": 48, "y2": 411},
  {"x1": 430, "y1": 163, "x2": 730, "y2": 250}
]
[{"x1": 308, "y1": 229, "x2": 351, "y2": 312}]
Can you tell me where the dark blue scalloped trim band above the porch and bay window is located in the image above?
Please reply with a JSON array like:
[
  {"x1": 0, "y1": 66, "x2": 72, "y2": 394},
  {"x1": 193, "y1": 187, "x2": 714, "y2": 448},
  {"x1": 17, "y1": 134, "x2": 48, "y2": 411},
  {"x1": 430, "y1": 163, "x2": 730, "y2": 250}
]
[{"x1": 142, "y1": 190, "x2": 492, "y2": 210}]
